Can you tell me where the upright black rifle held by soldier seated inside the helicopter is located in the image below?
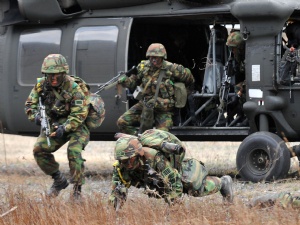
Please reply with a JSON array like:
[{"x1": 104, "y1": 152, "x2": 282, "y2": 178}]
[{"x1": 215, "y1": 51, "x2": 233, "y2": 126}]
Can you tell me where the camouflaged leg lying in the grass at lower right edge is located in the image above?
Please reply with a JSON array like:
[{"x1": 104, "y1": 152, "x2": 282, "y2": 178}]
[{"x1": 250, "y1": 192, "x2": 300, "y2": 209}]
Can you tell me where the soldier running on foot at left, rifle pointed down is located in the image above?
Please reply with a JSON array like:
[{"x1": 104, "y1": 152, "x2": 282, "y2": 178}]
[{"x1": 25, "y1": 54, "x2": 90, "y2": 199}]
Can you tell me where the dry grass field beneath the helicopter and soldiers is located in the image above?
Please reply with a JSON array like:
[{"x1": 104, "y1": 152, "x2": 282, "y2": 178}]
[{"x1": 0, "y1": 134, "x2": 300, "y2": 225}]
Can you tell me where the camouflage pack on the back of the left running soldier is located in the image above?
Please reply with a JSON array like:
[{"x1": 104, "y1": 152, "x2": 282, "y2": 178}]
[{"x1": 71, "y1": 76, "x2": 105, "y2": 129}]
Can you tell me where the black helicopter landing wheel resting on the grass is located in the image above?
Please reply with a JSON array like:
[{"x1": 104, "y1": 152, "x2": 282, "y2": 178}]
[{"x1": 236, "y1": 131, "x2": 291, "y2": 182}]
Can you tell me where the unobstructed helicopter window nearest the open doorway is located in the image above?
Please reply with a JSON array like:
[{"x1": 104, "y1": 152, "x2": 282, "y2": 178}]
[{"x1": 72, "y1": 26, "x2": 119, "y2": 85}]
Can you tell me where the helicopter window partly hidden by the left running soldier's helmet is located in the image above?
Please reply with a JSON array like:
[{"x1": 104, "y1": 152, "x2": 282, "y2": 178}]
[{"x1": 17, "y1": 29, "x2": 62, "y2": 86}]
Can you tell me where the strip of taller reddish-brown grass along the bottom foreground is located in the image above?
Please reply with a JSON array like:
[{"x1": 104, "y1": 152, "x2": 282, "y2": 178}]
[{"x1": 0, "y1": 180, "x2": 300, "y2": 225}]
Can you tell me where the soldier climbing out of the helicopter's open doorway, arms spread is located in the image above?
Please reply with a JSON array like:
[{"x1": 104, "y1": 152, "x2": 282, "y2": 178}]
[{"x1": 117, "y1": 43, "x2": 194, "y2": 135}]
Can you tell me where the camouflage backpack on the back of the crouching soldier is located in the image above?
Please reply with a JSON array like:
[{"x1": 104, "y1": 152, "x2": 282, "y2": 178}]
[{"x1": 138, "y1": 129, "x2": 186, "y2": 172}]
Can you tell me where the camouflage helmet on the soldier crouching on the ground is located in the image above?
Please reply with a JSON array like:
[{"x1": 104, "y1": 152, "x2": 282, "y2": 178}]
[{"x1": 115, "y1": 136, "x2": 143, "y2": 160}]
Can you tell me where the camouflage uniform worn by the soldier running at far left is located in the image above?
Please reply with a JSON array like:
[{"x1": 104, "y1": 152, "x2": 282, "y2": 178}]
[{"x1": 25, "y1": 54, "x2": 90, "y2": 197}]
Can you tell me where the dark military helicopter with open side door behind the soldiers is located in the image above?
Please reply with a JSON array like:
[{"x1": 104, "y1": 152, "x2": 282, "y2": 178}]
[{"x1": 0, "y1": 0, "x2": 300, "y2": 182}]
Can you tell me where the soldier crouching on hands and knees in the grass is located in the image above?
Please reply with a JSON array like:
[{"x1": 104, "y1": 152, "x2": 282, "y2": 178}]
[{"x1": 109, "y1": 135, "x2": 233, "y2": 207}]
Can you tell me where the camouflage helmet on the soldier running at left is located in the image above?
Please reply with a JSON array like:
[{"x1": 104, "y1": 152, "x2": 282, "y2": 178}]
[{"x1": 41, "y1": 54, "x2": 69, "y2": 73}]
